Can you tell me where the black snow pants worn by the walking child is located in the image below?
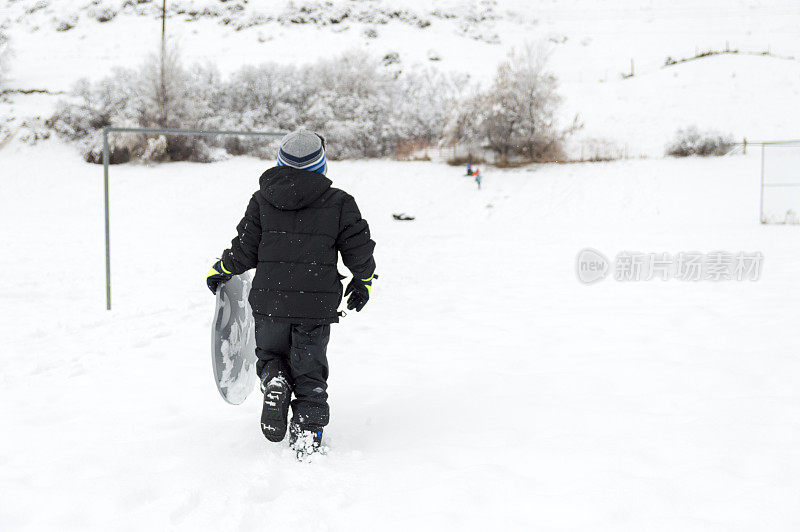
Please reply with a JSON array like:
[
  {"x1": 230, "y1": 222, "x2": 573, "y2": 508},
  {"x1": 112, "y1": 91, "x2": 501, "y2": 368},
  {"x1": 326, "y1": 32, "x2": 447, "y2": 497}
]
[{"x1": 255, "y1": 316, "x2": 331, "y2": 430}]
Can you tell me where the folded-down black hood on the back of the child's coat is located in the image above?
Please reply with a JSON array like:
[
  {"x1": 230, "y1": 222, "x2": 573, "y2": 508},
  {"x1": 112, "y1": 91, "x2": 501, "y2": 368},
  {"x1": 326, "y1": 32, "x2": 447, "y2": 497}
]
[{"x1": 259, "y1": 166, "x2": 332, "y2": 211}]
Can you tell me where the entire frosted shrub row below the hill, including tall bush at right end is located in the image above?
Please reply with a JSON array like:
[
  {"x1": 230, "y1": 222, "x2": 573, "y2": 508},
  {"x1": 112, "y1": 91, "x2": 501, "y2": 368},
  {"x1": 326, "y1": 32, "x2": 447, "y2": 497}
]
[{"x1": 47, "y1": 42, "x2": 579, "y2": 165}]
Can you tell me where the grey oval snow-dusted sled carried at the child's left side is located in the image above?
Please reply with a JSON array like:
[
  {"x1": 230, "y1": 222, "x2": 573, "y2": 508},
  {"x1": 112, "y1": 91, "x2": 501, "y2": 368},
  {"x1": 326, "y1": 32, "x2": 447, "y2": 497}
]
[{"x1": 211, "y1": 274, "x2": 257, "y2": 405}]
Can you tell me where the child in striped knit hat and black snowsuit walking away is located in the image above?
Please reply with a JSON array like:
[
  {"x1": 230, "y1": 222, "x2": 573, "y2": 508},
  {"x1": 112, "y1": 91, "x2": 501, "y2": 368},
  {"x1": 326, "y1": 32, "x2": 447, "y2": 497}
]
[{"x1": 206, "y1": 129, "x2": 377, "y2": 455}]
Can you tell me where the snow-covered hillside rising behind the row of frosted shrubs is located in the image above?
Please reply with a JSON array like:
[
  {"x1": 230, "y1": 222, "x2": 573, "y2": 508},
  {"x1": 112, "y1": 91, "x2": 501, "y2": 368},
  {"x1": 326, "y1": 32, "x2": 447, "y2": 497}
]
[{"x1": 0, "y1": 0, "x2": 800, "y2": 155}]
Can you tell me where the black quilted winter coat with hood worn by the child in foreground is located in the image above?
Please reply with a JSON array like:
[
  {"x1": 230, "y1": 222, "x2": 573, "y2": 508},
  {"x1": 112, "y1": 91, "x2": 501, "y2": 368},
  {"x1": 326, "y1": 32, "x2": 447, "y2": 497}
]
[{"x1": 222, "y1": 166, "x2": 375, "y2": 324}]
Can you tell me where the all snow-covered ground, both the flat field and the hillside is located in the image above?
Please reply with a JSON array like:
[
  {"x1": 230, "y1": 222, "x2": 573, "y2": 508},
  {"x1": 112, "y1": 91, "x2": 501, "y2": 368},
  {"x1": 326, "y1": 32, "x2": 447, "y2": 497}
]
[{"x1": 0, "y1": 0, "x2": 800, "y2": 532}]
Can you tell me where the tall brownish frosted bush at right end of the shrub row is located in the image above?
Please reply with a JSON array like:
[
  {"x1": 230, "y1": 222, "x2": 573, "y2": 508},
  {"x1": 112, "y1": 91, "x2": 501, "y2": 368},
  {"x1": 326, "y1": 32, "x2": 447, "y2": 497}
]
[{"x1": 448, "y1": 45, "x2": 579, "y2": 164}]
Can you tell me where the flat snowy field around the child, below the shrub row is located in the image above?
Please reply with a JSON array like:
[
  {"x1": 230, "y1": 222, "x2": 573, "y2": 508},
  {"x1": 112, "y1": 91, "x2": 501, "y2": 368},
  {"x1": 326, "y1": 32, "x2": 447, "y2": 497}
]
[{"x1": 0, "y1": 142, "x2": 800, "y2": 532}]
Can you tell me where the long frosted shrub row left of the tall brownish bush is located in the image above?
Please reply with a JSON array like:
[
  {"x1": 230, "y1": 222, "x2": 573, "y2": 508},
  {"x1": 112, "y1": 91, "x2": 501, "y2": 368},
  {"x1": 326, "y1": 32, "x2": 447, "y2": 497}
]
[{"x1": 48, "y1": 47, "x2": 466, "y2": 162}]
